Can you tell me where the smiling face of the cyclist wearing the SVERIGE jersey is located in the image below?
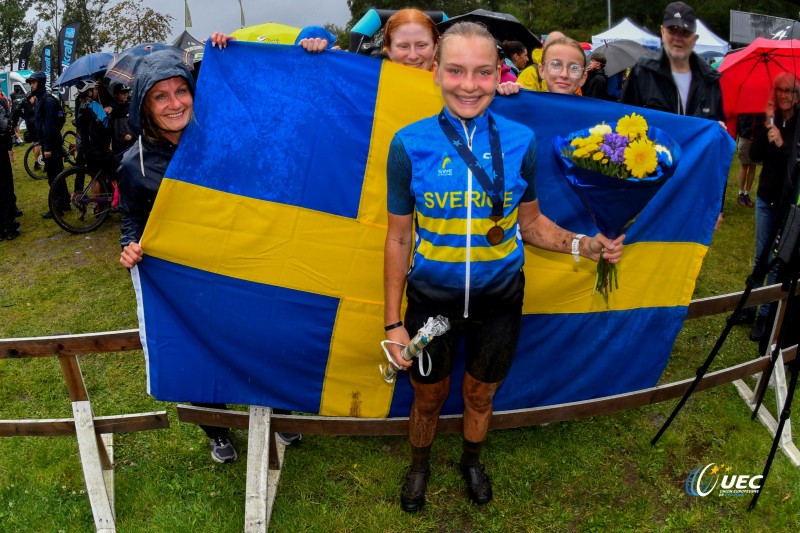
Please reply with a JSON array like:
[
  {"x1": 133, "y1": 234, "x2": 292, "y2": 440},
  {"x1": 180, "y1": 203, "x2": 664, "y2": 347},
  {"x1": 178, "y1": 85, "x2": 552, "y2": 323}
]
[{"x1": 433, "y1": 35, "x2": 500, "y2": 120}]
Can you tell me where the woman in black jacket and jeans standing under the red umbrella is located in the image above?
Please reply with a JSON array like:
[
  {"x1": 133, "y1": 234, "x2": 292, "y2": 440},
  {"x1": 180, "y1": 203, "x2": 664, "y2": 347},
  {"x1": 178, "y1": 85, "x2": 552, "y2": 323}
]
[{"x1": 750, "y1": 72, "x2": 800, "y2": 341}]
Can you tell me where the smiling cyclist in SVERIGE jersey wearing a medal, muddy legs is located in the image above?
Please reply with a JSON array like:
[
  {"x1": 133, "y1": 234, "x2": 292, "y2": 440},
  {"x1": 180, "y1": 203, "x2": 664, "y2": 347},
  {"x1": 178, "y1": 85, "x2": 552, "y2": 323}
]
[{"x1": 384, "y1": 22, "x2": 624, "y2": 512}]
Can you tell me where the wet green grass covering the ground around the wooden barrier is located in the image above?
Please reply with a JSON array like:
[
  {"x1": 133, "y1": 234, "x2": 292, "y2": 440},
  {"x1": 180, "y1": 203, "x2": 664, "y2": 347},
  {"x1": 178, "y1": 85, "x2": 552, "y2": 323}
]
[{"x1": 0, "y1": 143, "x2": 800, "y2": 532}]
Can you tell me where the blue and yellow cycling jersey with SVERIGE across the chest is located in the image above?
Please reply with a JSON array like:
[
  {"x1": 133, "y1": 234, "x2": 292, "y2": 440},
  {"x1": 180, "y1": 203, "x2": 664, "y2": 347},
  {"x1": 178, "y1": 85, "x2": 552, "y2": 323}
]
[{"x1": 387, "y1": 109, "x2": 536, "y2": 316}]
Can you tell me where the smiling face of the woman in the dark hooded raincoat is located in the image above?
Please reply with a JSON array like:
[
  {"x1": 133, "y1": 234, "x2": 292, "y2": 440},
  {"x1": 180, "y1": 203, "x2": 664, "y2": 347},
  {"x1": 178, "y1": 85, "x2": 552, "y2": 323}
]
[{"x1": 144, "y1": 76, "x2": 194, "y2": 144}]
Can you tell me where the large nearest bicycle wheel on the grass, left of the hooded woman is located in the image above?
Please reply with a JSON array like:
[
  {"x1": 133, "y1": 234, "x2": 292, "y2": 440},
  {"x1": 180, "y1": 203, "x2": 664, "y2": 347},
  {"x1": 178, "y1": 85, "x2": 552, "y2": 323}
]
[{"x1": 47, "y1": 167, "x2": 114, "y2": 233}]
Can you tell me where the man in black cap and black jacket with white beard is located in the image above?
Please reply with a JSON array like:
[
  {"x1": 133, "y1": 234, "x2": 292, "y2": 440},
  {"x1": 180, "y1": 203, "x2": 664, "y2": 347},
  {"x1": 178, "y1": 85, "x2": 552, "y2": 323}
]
[{"x1": 620, "y1": 2, "x2": 725, "y2": 121}]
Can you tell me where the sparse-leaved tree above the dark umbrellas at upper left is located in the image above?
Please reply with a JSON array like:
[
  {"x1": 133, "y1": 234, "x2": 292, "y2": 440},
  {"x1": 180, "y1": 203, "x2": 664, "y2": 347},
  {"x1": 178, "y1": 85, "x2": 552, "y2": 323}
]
[{"x1": 100, "y1": 0, "x2": 175, "y2": 50}]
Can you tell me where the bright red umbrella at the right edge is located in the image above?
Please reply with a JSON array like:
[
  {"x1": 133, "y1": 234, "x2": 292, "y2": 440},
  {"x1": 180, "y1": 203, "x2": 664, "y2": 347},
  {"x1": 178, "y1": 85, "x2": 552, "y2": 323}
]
[{"x1": 719, "y1": 37, "x2": 800, "y2": 119}]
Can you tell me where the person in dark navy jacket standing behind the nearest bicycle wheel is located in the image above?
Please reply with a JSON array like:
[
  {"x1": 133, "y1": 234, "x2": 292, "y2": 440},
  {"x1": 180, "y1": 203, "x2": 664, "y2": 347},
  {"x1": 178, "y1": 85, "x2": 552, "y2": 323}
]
[{"x1": 28, "y1": 71, "x2": 69, "y2": 218}]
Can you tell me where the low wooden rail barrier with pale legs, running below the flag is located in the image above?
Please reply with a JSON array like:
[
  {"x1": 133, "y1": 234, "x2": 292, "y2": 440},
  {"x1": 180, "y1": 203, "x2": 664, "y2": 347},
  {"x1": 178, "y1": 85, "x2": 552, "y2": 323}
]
[{"x1": 0, "y1": 285, "x2": 800, "y2": 532}]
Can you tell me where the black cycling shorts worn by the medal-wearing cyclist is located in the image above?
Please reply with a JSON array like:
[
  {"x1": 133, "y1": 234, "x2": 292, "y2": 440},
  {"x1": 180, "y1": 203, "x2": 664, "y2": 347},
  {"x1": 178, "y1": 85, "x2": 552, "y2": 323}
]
[{"x1": 405, "y1": 302, "x2": 522, "y2": 384}]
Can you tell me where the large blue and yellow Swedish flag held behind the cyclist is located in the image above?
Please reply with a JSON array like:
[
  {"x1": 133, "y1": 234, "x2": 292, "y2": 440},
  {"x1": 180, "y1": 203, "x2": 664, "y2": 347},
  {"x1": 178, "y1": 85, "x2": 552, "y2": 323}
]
[{"x1": 132, "y1": 42, "x2": 734, "y2": 417}]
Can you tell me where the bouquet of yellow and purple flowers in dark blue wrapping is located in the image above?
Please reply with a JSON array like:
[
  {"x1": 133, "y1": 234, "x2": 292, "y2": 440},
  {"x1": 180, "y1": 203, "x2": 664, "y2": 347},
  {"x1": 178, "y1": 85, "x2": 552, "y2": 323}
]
[{"x1": 553, "y1": 113, "x2": 680, "y2": 308}]
